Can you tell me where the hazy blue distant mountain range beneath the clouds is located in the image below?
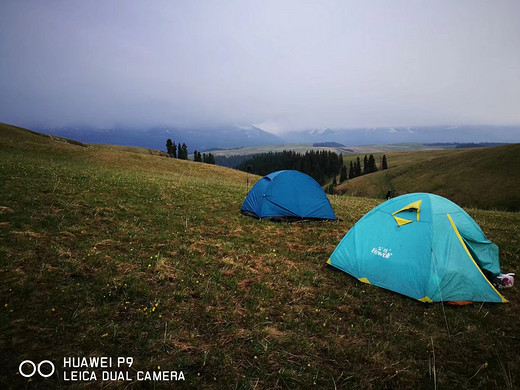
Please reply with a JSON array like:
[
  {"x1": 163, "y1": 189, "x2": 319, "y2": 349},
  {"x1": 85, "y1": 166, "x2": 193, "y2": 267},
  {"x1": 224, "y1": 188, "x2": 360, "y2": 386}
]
[{"x1": 35, "y1": 126, "x2": 520, "y2": 153}]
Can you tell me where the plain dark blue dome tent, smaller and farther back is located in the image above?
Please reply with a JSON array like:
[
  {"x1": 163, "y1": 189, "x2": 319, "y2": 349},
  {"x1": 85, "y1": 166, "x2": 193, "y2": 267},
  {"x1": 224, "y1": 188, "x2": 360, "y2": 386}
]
[{"x1": 240, "y1": 170, "x2": 336, "y2": 220}]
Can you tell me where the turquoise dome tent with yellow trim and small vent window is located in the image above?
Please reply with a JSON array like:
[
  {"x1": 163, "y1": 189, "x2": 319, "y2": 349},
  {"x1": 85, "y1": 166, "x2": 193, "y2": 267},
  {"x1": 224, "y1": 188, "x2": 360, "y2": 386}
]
[{"x1": 328, "y1": 193, "x2": 507, "y2": 302}]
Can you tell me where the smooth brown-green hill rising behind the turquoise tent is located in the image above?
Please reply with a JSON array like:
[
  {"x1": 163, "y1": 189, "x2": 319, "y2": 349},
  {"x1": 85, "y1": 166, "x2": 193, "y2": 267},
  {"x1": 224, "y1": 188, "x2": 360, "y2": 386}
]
[{"x1": 338, "y1": 144, "x2": 520, "y2": 211}]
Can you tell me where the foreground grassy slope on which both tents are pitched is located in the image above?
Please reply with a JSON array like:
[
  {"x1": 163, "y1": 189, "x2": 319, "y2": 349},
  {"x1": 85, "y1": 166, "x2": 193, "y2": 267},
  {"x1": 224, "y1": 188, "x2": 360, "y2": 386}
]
[{"x1": 0, "y1": 125, "x2": 520, "y2": 389}]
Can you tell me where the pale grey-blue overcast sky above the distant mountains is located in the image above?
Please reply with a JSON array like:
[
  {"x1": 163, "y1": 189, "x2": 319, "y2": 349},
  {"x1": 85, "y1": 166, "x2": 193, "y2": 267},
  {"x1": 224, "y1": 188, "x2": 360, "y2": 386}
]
[{"x1": 0, "y1": 0, "x2": 520, "y2": 132}]
